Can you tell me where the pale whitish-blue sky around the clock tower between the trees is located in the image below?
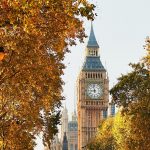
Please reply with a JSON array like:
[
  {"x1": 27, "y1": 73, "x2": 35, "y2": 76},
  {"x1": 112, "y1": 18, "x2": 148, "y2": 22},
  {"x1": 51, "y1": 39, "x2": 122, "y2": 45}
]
[{"x1": 36, "y1": 0, "x2": 150, "y2": 150}]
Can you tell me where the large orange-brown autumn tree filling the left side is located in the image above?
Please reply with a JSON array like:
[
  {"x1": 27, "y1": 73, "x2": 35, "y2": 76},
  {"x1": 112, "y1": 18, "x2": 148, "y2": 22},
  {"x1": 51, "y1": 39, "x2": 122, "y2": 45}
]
[{"x1": 0, "y1": 0, "x2": 94, "y2": 150}]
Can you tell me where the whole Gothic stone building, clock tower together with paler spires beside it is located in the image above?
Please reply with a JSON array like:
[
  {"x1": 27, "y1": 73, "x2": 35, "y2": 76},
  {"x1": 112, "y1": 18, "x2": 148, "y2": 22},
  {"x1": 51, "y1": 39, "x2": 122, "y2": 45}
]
[{"x1": 46, "y1": 25, "x2": 115, "y2": 150}]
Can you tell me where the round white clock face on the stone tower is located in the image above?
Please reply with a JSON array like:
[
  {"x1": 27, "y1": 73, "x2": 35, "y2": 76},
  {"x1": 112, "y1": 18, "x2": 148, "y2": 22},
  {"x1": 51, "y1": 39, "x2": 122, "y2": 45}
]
[{"x1": 87, "y1": 83, "x2": 103, "y2": 99}]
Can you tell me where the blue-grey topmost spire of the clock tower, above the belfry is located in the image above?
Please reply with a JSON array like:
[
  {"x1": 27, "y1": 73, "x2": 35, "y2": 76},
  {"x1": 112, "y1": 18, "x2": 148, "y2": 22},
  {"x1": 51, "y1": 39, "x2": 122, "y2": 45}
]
[{"x1": 87, "y1": 23, "x2": 99, "y2": 48}]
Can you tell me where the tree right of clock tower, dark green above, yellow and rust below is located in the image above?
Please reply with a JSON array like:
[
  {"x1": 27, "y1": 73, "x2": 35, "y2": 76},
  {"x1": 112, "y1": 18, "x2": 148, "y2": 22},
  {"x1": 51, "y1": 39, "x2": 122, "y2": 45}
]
[{"x1": 110, "y1": 39, "x2": 150, "y2": 150}]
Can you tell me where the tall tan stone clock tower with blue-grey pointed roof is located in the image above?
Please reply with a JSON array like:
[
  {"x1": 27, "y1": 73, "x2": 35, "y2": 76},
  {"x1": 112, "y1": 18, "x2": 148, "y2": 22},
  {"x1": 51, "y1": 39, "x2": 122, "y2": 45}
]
[{"x1": 77, "y1": 25, "x2": 109, "y2": 150}]
